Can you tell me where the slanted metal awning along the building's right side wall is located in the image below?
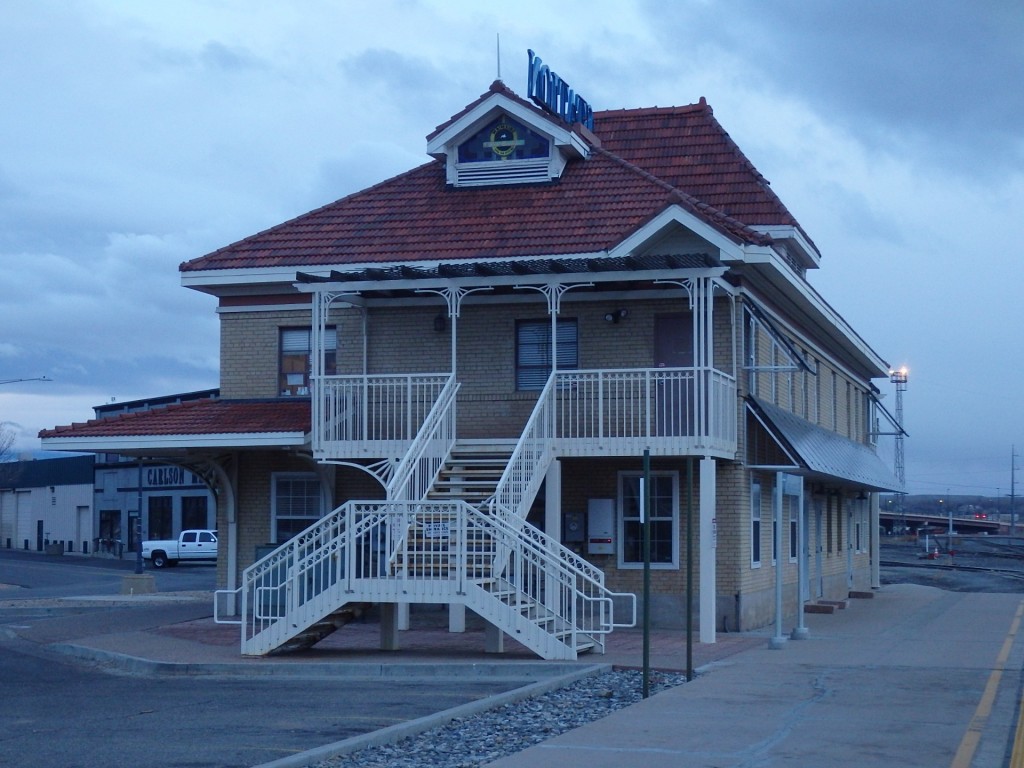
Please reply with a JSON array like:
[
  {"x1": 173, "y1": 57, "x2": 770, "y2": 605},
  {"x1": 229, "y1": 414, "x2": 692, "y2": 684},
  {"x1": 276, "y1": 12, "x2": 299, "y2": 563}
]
[{"x1": 746, "y1": 396, "x2": 902, "y2": 492}]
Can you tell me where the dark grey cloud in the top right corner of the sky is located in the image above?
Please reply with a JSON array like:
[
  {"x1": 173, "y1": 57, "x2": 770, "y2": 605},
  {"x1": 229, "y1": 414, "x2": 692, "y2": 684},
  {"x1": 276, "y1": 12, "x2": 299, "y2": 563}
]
[{"x1": 650, "y1": 0, "x2": 1024, "y2": 174}]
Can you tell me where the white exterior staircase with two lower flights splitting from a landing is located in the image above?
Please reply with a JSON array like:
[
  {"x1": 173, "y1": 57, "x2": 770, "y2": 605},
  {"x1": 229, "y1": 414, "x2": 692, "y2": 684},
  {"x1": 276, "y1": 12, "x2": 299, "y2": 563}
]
[{"x1": 217, "y1": 377, "x2": 636, "y2": 659}]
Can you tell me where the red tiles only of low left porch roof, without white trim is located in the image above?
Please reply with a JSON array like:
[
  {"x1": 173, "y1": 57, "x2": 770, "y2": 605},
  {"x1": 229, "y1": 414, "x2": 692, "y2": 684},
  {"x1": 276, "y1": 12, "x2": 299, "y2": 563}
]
[{"x1": 39, "y1": 398, "x2": 310, "y2": 438}]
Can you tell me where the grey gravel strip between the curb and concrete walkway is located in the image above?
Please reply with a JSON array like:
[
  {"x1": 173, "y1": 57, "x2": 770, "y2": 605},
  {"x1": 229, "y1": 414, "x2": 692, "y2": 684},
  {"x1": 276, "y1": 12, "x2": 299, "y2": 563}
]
[{"x1": 314, "y1": 671, "x2": 686, "y2": 768}]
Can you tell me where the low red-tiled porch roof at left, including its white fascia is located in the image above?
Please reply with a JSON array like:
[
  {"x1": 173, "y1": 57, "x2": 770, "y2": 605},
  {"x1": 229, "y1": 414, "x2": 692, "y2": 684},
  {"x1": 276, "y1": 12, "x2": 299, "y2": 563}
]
[{"x1": 39, "y1": 397, "x2": 310, "y2": 453}]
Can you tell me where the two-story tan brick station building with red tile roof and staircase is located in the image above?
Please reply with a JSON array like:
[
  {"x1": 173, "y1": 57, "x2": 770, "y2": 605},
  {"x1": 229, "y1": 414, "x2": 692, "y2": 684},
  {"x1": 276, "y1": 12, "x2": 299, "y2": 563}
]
[{"x1": 41, "y1": 59, "x2": 895, "y2": 657}]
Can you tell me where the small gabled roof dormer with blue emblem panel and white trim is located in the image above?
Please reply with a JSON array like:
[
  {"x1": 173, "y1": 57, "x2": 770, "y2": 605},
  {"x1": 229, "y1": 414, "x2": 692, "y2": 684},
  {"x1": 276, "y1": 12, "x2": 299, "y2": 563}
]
[{"x1": 427, "y1": 80, "x2": 595, "y2": 186}]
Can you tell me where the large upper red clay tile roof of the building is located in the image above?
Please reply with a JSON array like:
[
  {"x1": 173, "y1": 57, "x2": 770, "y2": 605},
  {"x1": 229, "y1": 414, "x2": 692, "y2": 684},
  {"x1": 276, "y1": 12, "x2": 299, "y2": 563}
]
[{"x1": 180, "y1": 93, "x2": 796, "y2": 272}]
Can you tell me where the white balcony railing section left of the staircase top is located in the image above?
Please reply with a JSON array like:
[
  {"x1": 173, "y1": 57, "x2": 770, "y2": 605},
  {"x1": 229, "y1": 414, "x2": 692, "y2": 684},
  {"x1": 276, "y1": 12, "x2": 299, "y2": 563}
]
[{"x1": 312, "y1": 374, "x2": 451, "y2": 459}]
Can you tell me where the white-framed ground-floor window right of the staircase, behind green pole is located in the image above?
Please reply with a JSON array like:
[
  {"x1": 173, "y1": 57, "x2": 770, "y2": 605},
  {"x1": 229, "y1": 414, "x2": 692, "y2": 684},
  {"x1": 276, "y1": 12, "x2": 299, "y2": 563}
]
[{"x1": 618, "y1": 472, "x2": 679, "y2": 568}]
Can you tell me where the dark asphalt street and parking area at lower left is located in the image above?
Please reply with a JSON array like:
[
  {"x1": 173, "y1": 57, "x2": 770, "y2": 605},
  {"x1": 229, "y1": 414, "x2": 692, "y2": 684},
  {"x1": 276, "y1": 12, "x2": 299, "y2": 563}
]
[{"x1": 0, "y1": 552, "x2": 526, "y2": 768}]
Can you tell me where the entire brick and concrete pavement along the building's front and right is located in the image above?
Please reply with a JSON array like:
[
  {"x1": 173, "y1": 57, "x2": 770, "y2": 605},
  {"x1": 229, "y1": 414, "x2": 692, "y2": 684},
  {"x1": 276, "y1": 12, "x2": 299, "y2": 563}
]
[{"x1": 9, "y1": 585, "x2": 1024, "y2": 768}]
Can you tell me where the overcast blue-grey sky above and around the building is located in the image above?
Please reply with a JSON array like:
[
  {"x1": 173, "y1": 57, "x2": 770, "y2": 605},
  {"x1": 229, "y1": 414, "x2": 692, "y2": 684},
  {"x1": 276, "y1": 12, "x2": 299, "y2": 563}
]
[{"x1": 0, "y1": 0, "x2": 1024, "y2": 496}]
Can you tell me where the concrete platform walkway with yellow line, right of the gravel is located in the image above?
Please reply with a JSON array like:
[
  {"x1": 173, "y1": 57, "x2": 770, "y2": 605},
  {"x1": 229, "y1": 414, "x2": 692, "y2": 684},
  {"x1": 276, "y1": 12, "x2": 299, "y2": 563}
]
[{"x1": 493, "y1": 585, "x2": 1024, "y2": 768}]
